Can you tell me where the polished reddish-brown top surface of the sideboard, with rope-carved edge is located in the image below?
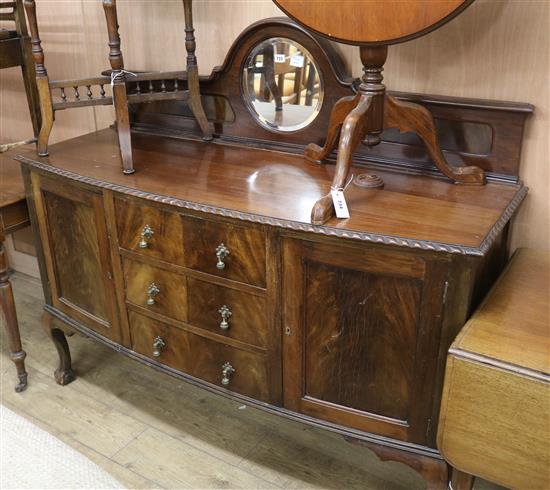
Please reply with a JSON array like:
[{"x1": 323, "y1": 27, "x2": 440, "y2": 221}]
[{"x1": 17, "y1": 129, "x2": 527, "y2": 255}]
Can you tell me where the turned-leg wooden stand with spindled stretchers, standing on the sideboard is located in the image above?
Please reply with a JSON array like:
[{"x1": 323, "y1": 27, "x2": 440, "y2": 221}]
[{"x1": 24, "y1": 0, "x2": 212, "y2": 174}]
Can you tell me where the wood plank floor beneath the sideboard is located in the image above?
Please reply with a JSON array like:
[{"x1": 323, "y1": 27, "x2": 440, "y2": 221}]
[{"x1": 0, "y1": 273, "x2": 499, "y2": 490}]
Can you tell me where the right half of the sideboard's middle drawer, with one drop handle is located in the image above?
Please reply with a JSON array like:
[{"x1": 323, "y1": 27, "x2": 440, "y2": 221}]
[{"x1": 187, "y1": 277, "x2": 269, "y2": 347}]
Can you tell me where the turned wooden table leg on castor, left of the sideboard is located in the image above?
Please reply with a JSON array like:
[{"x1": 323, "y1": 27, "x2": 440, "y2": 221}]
[{"x1": 0, "y1": 234, "x2": 27, "y2": 393}]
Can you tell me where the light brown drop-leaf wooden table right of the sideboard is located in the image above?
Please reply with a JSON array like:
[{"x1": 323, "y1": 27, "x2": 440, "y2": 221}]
[{"x1": 438, "y1": 249, "x2": 550, "y2": 490}]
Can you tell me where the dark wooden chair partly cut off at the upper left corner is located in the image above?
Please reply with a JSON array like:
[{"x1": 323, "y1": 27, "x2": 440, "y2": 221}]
[{"x1": 0, "y1": 0, "x2": 41, "y2": 137}]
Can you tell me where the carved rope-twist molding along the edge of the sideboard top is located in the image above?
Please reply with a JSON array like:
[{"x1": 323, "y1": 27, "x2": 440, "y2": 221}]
[{"x1": 15, "y1": 155, "x2": 529, "y2": 256}]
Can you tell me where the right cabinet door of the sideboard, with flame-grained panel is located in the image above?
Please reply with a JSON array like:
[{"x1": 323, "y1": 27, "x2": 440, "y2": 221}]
[{"x1": 283, "y1": 239, "x2": 445, "y2": 443}]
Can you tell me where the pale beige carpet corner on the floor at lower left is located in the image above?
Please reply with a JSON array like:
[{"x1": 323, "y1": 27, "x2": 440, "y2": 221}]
[{"x1": 0, "y1": 405, "x2": 124, "y2": 490}]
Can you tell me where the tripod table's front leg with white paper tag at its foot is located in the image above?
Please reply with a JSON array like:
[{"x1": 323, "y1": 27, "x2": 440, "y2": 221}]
[{"x1": 311, "y1": 95, "x2": 373, "y2": 225}]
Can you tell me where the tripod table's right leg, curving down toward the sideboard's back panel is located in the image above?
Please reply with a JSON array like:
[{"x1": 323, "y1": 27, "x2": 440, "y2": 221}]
[{"x1": 384, "y1": 95, "x2": 485, "y2": 185}]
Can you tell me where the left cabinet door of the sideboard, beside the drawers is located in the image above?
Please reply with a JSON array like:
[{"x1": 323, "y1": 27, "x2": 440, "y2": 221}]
[{"x1": 32, "y1": 174, "x2": 121, "y2": 342}]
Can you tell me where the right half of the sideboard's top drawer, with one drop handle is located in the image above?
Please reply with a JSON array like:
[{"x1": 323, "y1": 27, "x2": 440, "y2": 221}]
[{"x1": 182, "y1": 217, "x2": 265, "y2": 288}]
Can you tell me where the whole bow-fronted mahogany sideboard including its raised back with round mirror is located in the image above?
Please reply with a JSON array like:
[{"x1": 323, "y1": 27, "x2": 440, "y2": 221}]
[{"x1": 18, "y1": 19, "x2": 533, "y2": 488}]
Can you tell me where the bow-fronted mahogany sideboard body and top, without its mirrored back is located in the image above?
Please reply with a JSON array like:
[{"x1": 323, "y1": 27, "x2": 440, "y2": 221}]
[{"x1": 18, "y1": 129, "x2": 527, "y2": 488}]
